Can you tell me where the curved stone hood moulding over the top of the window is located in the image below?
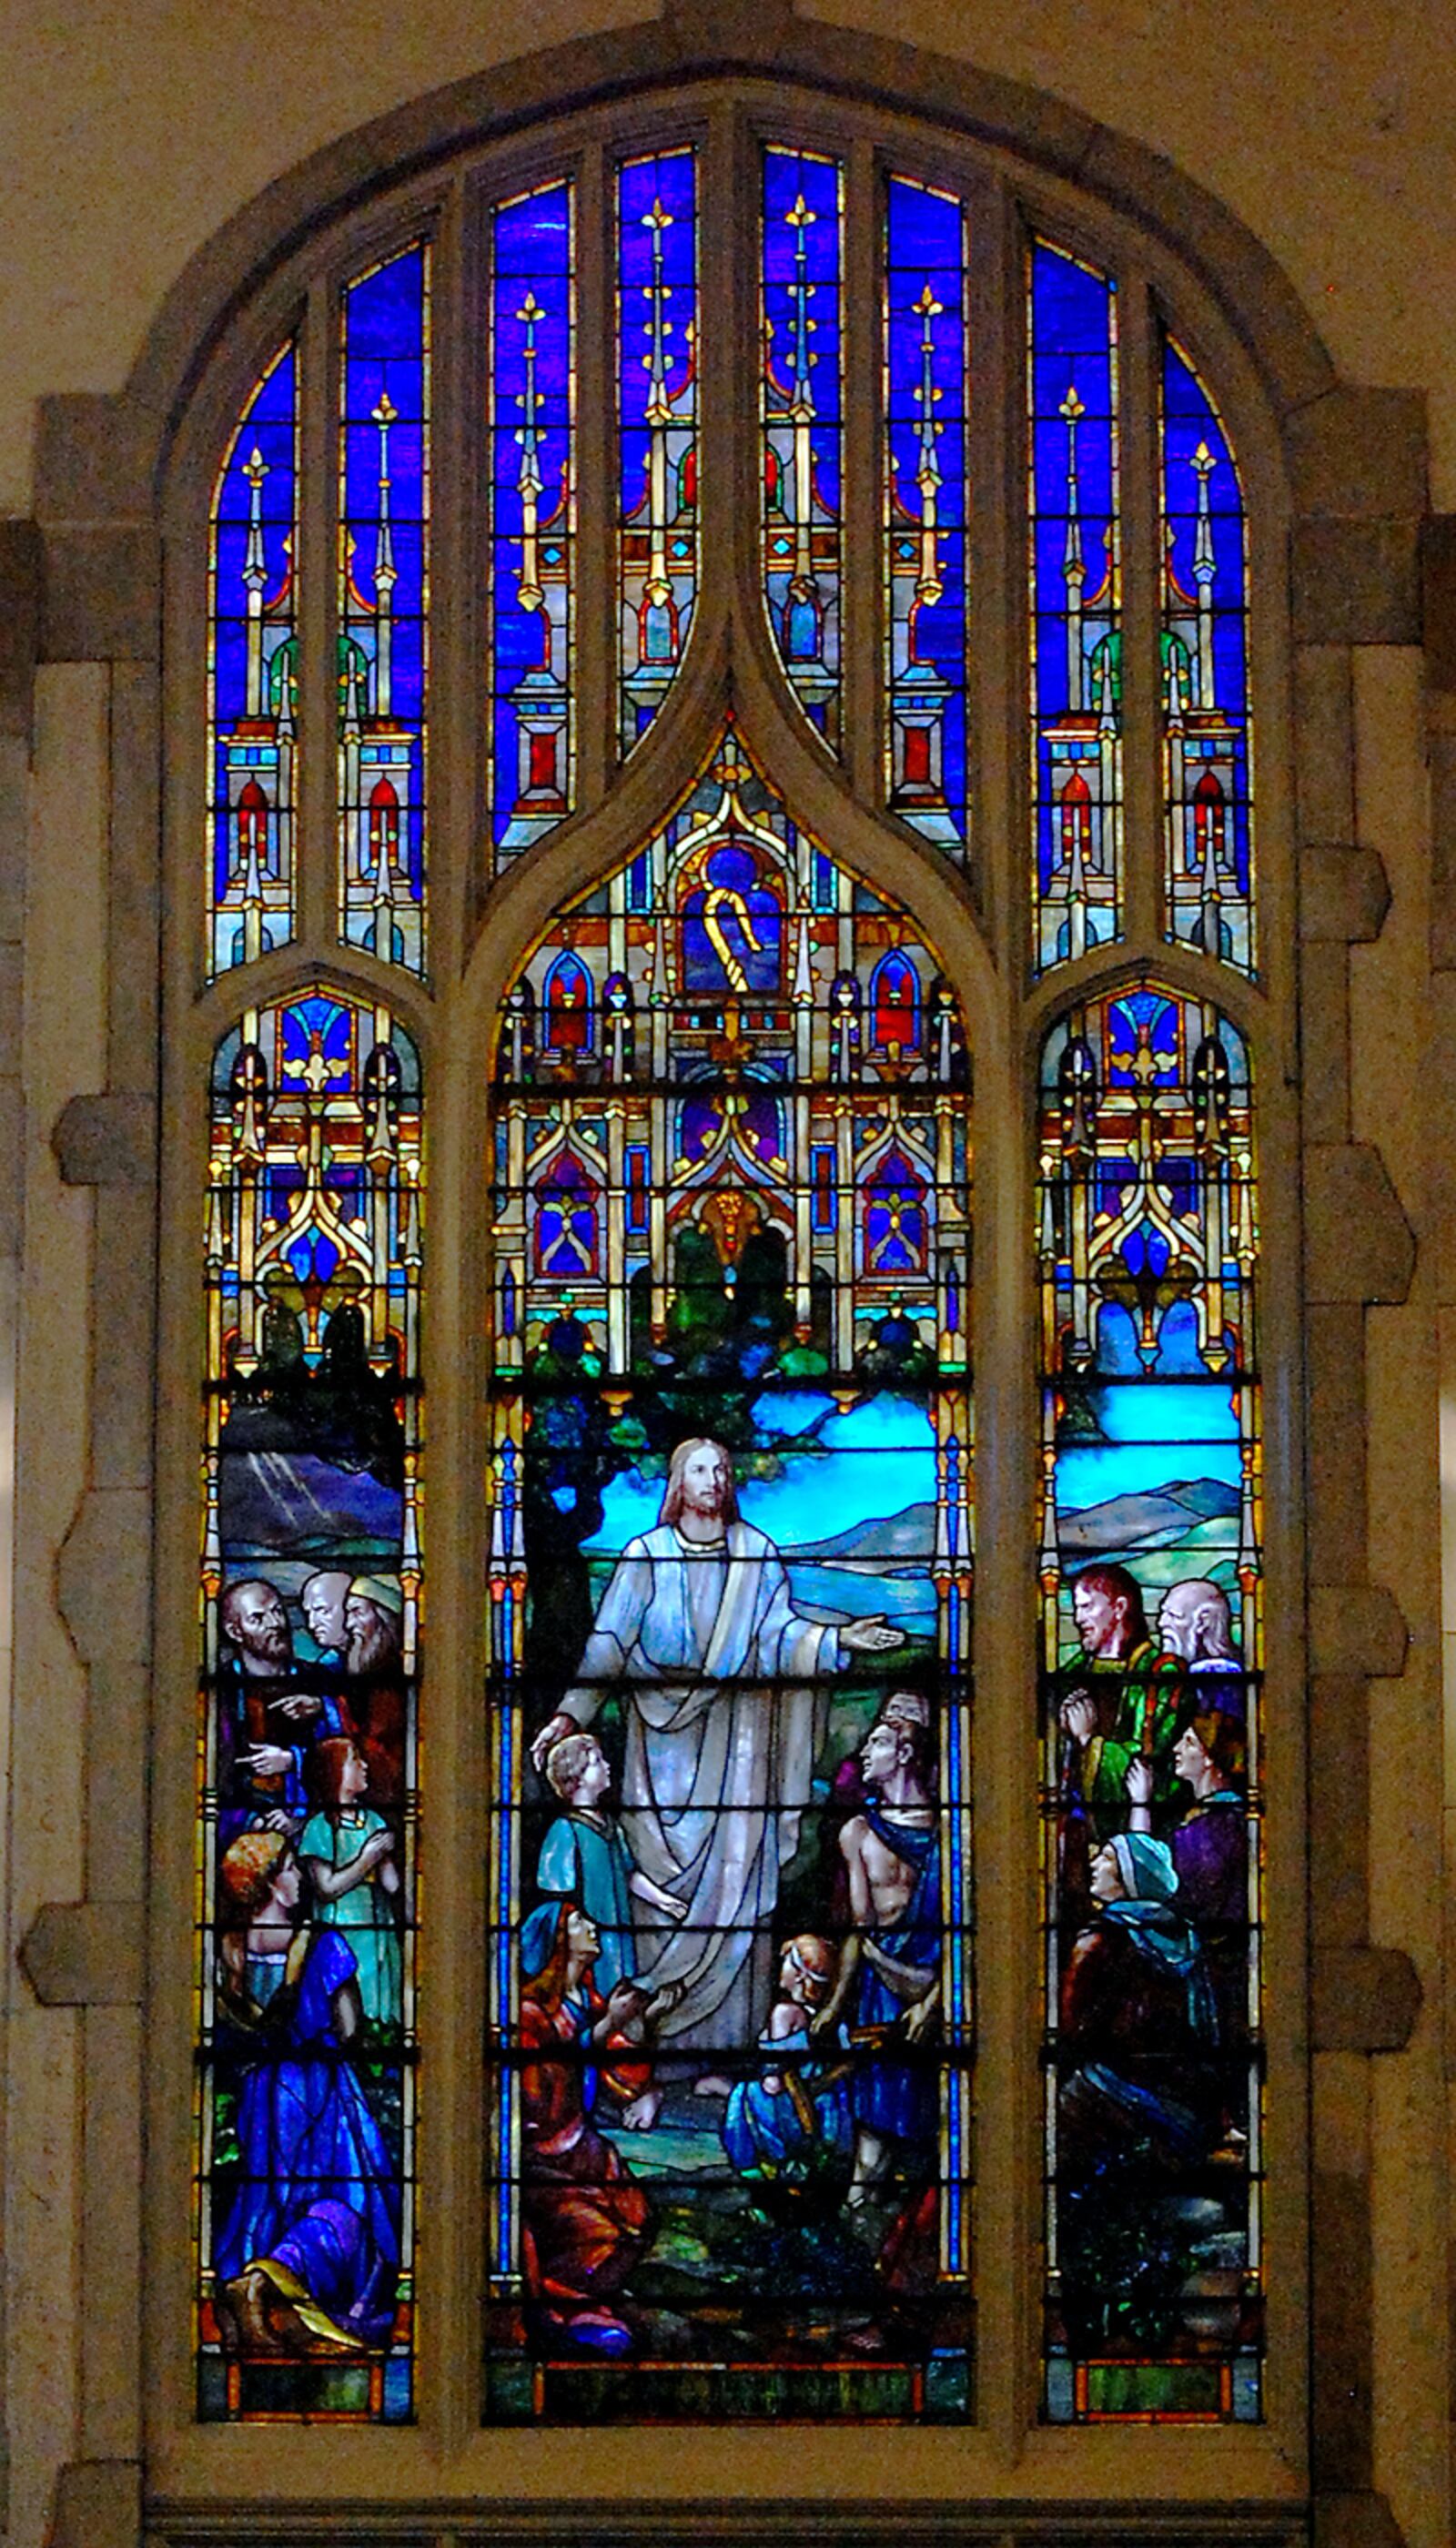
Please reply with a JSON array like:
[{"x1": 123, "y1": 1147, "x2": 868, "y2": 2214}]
[{"x1": 38, "y1": 0, "x2": 1336, "y2": 532}]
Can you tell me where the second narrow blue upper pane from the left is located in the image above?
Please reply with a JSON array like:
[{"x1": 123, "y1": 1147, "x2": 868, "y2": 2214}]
[{"x1": 339, "y1": 242, "x2": 431, "y2": 974}]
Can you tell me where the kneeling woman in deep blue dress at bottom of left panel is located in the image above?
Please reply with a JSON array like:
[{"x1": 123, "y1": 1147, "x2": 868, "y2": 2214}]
[{"x1": 212, "y1": 1832, "x2": 400, "y2": 2351}]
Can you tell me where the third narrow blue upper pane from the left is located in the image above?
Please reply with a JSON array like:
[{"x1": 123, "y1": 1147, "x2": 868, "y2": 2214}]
[{"x1": 490, "y1": 184, "x2": 576, "y2": 859}]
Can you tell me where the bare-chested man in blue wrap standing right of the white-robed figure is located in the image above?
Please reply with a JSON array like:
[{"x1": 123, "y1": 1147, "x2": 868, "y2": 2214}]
[{"x1": 818, "y1": 1714, "x2": 941, "y2": 2207}]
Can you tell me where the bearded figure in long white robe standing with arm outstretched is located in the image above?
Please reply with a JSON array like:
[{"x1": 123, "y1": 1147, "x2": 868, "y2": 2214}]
[{"x1": 531, "y1": 1440, "x2": 903, "y2": 2051}]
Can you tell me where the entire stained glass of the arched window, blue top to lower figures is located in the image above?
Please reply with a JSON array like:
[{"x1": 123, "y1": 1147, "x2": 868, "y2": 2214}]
[{"x1": 182, "y1": 69, "x2": 1262, "y2": 2456}]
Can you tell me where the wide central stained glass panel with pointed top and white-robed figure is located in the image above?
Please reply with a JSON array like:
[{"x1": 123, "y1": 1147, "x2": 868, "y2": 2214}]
[{"x1": 484, "y1": 726, "x2": 972, "y2": 2423}]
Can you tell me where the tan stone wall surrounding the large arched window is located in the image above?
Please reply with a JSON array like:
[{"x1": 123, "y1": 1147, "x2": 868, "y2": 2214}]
[{"x1": 0, "y1": 0, "x2": 1456, "y2": 2548}]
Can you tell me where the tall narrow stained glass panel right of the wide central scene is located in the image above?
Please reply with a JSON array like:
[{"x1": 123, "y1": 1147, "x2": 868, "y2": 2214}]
[{"x1": 1040, "y1": 981, "x2": 1262, "y2": 2423}]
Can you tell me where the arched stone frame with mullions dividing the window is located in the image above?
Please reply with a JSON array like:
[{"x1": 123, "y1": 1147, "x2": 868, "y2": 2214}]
[{"x1": 7, "y1": 7, "x2": 1423, "y2": 2543}]
